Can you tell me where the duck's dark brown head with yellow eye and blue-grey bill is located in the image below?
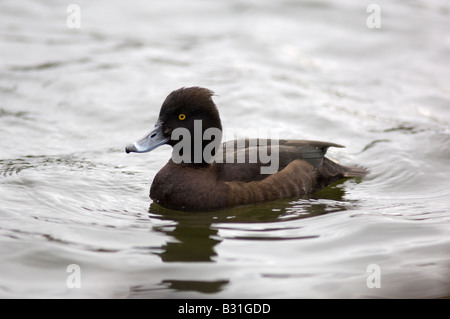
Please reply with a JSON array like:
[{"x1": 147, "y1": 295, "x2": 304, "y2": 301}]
[{"x1": 125, "y1": 87, "x2": 222, "y2": 164}]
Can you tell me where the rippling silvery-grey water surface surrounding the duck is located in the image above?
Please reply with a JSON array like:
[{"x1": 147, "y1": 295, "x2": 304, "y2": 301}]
[{"x1": 0, "y1": 0, "x2": 450, "y2": 298}]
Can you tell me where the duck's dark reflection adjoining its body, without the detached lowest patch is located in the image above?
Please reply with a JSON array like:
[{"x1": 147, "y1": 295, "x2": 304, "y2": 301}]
[{"x1": 149, "y1": 181, "x2": 351, "y2": 262}]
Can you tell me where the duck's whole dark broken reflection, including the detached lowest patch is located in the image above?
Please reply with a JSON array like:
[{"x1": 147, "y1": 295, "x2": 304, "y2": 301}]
[{"x1": 137, "y1": 181, "x2": 351, "y2": 297}]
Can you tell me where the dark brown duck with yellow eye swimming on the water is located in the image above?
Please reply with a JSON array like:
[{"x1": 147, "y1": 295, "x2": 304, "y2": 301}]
[{"x1": 125, "y1": 86, "x2": 368, "y2": 211}]
